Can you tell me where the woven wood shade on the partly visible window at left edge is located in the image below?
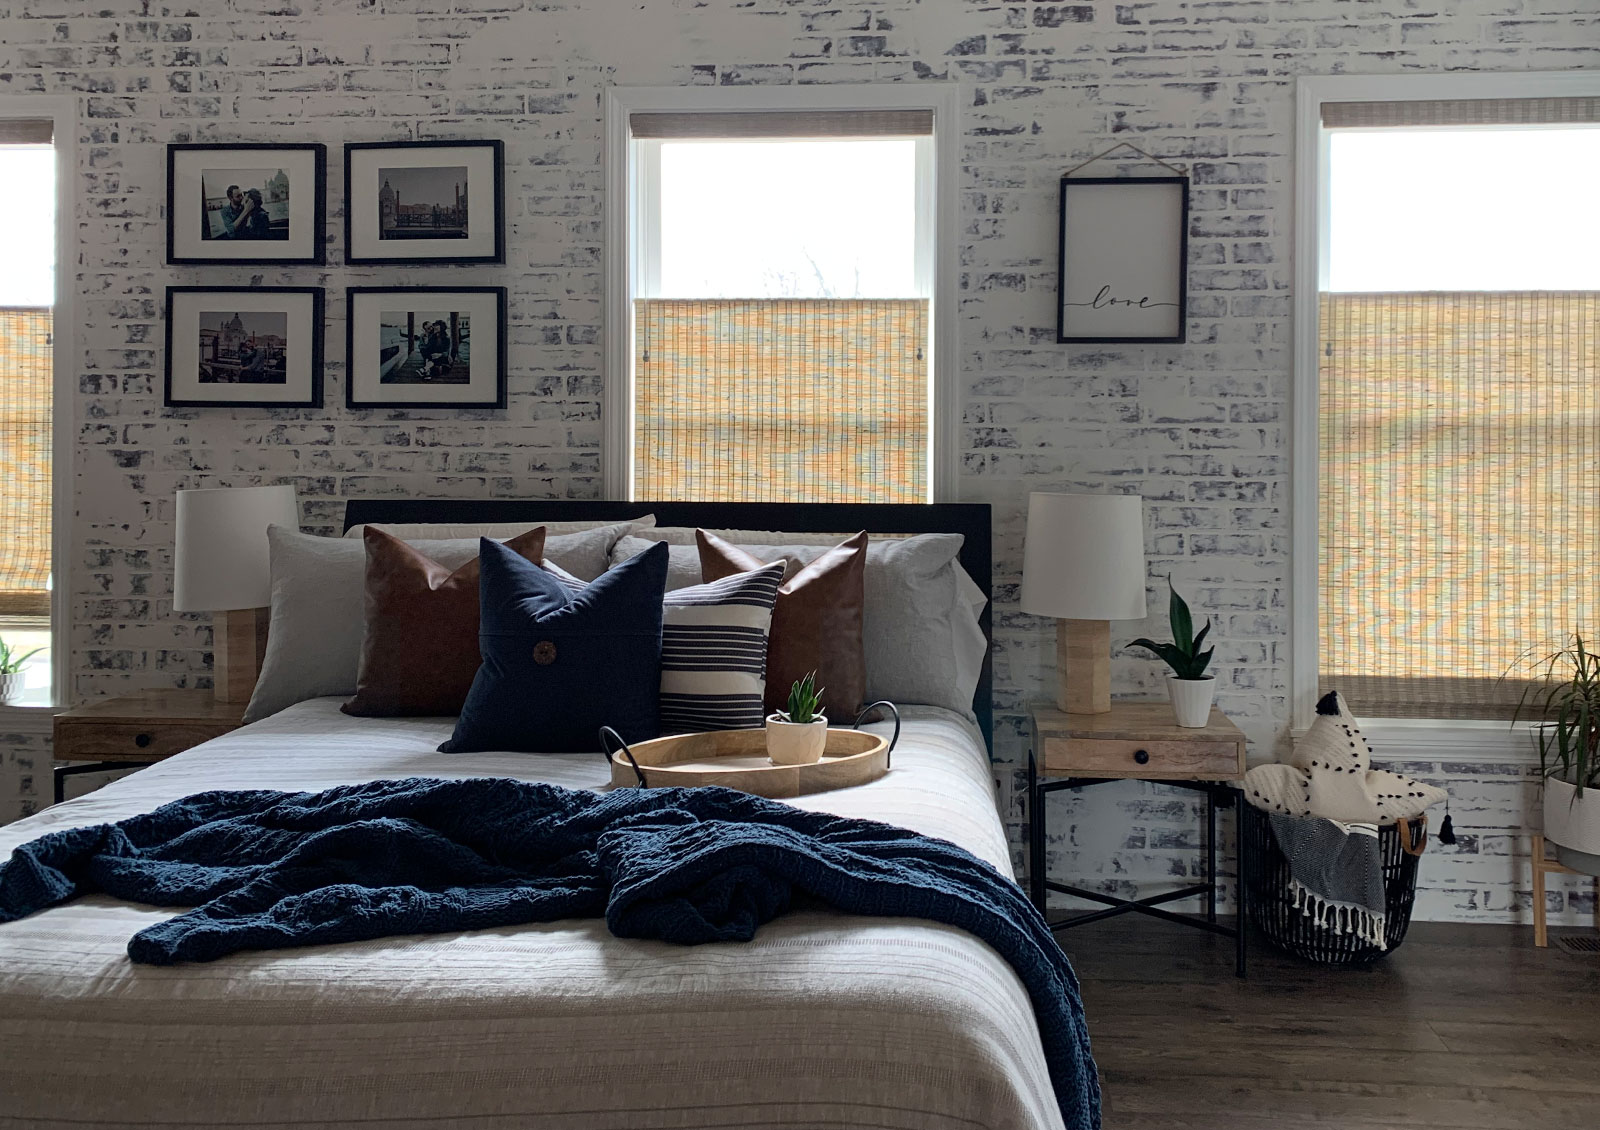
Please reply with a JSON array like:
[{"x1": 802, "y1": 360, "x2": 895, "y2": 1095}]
[{"x1": 0, "y1": 307, "x2": 53, "y2": 616}]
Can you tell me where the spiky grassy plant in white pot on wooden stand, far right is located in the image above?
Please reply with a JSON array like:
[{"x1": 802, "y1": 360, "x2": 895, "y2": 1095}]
[{"x1": 1512, "y1": 632, "x2": 1600, "y2": 876}]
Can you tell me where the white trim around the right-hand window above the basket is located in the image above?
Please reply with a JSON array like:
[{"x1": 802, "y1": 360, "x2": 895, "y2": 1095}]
[{"x1": 1290, "y1": 70, "x2": 1600, "y2": 762}]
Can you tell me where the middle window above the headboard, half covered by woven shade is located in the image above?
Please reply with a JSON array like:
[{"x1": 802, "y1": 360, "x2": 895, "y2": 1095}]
[{"x1": 608, "y1": 91, "x2": 947, "y2": 503}]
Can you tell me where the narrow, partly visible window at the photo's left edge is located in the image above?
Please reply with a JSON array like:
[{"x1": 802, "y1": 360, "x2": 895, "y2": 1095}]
[{"x1": 0, "y1": 118, "x2": 56, "y2": 704}]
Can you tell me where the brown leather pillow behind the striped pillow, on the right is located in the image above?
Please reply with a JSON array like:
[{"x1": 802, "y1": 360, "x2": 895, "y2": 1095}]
[{"x1": 694, "y1": 530, "x2": 867, "y2": 725}]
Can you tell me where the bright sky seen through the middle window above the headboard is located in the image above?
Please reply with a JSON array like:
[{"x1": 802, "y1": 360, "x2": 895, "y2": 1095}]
[{"x1": 651, "y1": 138, "x2": 922, "y2": 298}]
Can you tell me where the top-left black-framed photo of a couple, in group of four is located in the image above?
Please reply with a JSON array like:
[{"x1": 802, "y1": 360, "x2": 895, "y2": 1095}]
[{"x1": 166, "y1": 144, "x2": 328, "y2": 266}]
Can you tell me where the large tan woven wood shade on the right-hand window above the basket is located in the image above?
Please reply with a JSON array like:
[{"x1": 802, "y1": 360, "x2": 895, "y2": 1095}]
[{"x1": 1318, "y1": 291, "x2": 1600, "y2": 719}]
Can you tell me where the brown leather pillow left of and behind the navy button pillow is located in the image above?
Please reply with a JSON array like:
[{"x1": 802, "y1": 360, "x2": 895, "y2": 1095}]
[{"x1": 341, "y1": 525, "x2": 544, "y2": 717}]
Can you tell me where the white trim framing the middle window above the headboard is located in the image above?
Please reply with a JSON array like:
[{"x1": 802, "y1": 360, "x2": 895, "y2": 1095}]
[{"x1": 600, "y1": 83, "x2": 962, "y2": 503}]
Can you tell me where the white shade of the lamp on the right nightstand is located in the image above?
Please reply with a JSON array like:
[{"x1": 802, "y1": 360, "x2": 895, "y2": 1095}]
[{"x1": 1022, "y1": 491, "x2": 1144, "y2": 619}]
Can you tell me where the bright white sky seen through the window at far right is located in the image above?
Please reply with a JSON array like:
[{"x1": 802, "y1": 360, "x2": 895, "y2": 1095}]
[{"x1": 1328, "y1": 126, "x2": 1600, "y2": 291}]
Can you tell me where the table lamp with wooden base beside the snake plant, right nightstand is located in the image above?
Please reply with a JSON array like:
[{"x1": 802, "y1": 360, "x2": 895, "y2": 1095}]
[{"x1": 1022, "y1": 491, "x2": 1144, "y2": 714}]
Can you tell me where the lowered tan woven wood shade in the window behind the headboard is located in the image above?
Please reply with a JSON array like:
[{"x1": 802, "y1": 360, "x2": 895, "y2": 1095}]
[{"x1": 634, "y1": 299, "x2": 930, "y2": 503}]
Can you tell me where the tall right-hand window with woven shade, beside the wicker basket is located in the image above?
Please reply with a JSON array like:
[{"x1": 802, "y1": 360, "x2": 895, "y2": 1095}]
[{"x1": 1301, "y1": 80, "x2": 1600, "y2": 720}]
